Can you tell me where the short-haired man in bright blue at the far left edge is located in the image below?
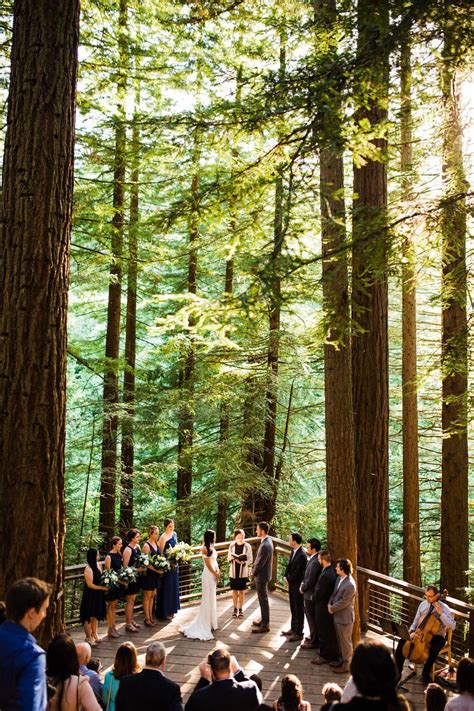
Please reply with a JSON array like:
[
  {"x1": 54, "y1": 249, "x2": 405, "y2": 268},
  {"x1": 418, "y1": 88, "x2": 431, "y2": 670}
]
[{"x1": 0, "y1": 578, "x2": 51, "y2": 711}]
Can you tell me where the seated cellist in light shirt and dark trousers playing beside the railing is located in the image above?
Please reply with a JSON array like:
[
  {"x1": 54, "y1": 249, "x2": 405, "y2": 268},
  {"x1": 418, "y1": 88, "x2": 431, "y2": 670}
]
[{"x1": 395, "y1": 585, "x2": 456, "y2": 684}]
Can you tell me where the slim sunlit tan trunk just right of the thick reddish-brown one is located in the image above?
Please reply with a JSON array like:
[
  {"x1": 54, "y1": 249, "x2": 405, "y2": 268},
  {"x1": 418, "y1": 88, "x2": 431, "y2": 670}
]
[{"x1": 400, "y1": 30, "x2": 421, "y2": 585}]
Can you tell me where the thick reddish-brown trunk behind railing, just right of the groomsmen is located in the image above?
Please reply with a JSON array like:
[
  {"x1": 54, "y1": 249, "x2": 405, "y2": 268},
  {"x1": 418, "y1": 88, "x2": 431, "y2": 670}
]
[{"x1": 352, "y1": 0, "x2": 389, "y2": 573}]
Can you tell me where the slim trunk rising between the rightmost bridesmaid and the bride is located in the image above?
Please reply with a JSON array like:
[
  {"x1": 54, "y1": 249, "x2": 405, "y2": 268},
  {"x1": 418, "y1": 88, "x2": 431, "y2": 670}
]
[{"x1": 177, "y1": 134, "x2": 200, "y2": 543}]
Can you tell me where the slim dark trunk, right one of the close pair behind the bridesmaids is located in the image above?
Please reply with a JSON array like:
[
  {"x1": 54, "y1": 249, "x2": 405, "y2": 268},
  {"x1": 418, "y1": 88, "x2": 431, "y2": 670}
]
[{"x1": 120, "y1": 85, "x2": 140, "y2": 531}]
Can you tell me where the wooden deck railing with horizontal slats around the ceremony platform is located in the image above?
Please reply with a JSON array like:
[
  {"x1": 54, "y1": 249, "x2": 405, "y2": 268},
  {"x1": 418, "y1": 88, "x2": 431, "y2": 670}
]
[{"x1": 64, "y1": 537, "x2": 474, "y2": 659}]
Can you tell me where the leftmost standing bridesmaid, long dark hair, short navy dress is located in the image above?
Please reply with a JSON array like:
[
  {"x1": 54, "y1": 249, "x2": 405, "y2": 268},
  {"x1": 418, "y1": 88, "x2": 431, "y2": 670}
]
[{"x1": 80, "y1": 548, "x2": 107, "y2": 647}]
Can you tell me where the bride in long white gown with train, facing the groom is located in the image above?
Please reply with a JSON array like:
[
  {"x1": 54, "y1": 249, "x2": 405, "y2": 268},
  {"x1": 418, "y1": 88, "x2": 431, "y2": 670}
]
[{"x1": 179, "y1": 529, "x2": 220, "y2": 640}]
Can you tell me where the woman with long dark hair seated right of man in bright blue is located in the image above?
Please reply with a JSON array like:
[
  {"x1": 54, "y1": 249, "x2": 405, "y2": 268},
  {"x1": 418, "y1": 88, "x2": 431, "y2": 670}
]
[{"x1": 46, "y1": 634, "x2": 101, "y2": 711}]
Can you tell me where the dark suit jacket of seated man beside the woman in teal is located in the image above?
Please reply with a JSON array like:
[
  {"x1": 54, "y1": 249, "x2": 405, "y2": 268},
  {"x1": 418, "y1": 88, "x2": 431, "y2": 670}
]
[{"x1": 115, "y1": 669, "x2": 183, "y2": 711}]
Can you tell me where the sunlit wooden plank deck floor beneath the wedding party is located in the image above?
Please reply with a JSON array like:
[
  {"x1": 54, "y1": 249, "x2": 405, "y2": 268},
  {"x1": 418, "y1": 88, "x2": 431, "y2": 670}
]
[{"x1": 70, "y1": 591, "x2": 446, "y2": 711}]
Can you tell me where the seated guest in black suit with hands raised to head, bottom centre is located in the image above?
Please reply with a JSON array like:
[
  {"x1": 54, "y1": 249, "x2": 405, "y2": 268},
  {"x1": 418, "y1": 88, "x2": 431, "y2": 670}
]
[{"x1": 186, "y1": 649, "x2": 262, "y2": 711}]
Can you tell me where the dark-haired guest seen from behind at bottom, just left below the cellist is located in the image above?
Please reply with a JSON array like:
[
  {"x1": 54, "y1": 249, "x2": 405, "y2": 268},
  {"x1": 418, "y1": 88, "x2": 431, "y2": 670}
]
[{"x1": 334, "y1": 642, "x2": 410, "y2": 711}]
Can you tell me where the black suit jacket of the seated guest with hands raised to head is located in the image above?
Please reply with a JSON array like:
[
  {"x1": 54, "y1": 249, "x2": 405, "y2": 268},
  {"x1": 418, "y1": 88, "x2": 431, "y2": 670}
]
[{"x1": 185, "y1": 669, "x2": 262, "y2": 711}]
